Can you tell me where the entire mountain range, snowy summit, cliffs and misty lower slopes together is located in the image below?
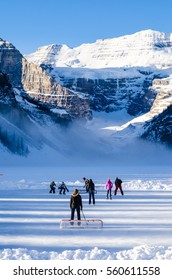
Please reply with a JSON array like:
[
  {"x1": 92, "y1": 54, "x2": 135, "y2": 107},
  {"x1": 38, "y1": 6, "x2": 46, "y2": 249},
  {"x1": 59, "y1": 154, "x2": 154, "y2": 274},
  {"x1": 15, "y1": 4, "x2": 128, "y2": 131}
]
[{"x1": 0, "y1": 30, "x2": 172, "y2": 161}]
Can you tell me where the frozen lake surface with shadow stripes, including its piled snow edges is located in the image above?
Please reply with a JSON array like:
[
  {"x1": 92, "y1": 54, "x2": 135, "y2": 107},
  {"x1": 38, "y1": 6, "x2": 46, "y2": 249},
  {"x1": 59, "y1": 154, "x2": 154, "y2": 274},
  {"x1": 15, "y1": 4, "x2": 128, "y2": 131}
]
[{"x1": 0, "y1": 179, "x2": 172, "y2": 259}]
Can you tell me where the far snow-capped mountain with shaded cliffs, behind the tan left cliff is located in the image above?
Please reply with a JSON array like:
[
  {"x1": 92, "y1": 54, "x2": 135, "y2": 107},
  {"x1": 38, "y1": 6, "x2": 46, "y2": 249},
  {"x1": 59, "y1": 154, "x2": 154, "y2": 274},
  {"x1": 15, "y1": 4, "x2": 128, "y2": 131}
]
[{"x1": 26, "y1": 30, "x2": 172, "y2": 148}]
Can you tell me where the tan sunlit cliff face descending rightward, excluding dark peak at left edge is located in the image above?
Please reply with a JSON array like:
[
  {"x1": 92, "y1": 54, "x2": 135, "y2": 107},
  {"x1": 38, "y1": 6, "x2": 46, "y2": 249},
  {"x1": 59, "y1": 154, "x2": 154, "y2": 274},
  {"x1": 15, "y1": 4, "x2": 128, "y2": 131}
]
[{"x1": 22, "y1": 59, "x2": 91, "y2": 119}]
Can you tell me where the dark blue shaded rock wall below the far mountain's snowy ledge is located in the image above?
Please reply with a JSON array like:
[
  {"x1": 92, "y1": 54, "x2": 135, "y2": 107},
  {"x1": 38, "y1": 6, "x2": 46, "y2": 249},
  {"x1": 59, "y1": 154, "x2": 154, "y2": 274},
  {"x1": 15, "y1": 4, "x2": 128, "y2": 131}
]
[{"x1": 58, "y1": 73, "x2": 160, "y2": 116}]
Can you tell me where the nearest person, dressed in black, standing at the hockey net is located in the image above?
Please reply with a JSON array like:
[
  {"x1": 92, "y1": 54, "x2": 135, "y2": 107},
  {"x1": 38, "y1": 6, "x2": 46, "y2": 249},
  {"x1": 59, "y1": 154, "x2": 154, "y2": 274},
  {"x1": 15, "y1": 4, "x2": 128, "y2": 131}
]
[{"x1": 70, "y1": 189, "x2": 82, "y2": 225}]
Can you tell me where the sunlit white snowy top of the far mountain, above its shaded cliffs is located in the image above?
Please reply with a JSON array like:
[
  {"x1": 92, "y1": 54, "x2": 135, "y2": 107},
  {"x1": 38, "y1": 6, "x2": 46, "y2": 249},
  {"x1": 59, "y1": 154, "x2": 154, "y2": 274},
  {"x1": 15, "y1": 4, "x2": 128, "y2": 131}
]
[{"x1": 26, "y1": 30, "x2": 172, "y2": 68}]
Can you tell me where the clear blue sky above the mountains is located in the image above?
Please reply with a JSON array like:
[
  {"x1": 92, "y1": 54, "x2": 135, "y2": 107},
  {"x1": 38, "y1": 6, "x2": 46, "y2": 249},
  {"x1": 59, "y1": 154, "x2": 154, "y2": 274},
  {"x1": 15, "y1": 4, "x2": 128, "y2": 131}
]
[{"x1": 0, "y1": 0, "x2": 172, "y2": 54}]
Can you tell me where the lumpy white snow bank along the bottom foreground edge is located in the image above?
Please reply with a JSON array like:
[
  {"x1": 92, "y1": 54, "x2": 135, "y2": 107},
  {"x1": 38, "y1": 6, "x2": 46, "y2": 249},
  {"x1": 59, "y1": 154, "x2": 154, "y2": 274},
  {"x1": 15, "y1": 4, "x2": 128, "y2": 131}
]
[{"x1": 0, "y1": 245, "x2": 172, "y2": 260}]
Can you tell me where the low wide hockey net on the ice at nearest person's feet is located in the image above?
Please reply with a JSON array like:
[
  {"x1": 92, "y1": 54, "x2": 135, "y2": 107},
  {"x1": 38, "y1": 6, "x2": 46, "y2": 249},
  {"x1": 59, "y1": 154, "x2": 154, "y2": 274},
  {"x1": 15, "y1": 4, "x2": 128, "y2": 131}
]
[{"x1": 60, "y1": 219, "x2": 103, "y2": 229}]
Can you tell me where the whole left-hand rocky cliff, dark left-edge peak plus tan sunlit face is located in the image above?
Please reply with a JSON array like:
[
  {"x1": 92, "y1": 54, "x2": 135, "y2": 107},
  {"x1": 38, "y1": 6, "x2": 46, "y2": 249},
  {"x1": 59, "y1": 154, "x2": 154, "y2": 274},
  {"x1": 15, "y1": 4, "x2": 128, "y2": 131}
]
[{"x1": 0, "y1": 39, "x2": 92, "y2": 119}]
